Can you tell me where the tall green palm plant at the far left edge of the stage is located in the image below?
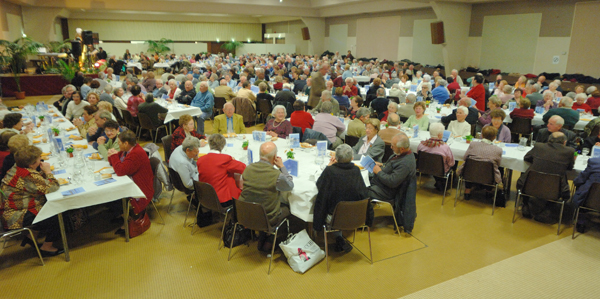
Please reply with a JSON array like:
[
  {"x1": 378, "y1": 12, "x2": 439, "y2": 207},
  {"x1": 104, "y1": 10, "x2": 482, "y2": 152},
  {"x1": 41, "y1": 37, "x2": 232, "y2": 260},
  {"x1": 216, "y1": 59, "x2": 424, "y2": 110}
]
[{"x1": 0, "y1": 37, "x2": 44, "y2": 99}]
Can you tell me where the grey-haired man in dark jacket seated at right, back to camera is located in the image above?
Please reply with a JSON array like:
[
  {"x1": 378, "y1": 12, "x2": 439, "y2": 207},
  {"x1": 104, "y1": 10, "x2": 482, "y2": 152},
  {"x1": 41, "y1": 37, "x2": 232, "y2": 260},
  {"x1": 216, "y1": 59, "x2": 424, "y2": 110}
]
[{"x1": 517, "y1": 132, "x2": 575, "y2": 223}]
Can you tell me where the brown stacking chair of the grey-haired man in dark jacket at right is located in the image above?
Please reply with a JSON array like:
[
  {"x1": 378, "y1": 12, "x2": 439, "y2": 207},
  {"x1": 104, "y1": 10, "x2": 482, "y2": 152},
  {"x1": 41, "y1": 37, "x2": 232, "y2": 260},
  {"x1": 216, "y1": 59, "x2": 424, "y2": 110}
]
[{"x1": 513, "y1": 170, "x2": 565, "y2": 235}]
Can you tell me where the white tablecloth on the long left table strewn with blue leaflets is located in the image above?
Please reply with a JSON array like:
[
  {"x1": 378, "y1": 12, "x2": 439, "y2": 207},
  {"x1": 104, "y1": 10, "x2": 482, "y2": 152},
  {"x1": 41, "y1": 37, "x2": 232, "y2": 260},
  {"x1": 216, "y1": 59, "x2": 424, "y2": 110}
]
[{"x1": 29, "y1": 109, "x2": 145, "y2": 223}]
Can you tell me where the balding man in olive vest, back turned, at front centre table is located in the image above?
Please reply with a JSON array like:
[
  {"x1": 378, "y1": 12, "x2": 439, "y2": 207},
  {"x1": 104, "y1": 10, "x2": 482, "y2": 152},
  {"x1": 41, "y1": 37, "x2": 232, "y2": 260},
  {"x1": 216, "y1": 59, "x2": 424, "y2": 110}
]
[{"x1": 239, "y1": 142, "x2": 294, "y2": 251}]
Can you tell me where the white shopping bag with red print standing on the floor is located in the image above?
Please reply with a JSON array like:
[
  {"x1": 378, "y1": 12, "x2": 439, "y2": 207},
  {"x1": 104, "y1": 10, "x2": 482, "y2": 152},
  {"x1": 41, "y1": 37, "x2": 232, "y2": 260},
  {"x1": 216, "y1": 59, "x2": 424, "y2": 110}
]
[{"x1": 279, "y1": 229, "x2": 325, "y2": 273}]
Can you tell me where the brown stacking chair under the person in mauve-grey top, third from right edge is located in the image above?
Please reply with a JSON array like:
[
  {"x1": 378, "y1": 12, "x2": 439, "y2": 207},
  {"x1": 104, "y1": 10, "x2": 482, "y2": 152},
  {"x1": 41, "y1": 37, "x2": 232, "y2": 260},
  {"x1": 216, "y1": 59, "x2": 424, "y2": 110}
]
[{"x1": 454, "y1": 159, "x2": 498, "y2": 216}]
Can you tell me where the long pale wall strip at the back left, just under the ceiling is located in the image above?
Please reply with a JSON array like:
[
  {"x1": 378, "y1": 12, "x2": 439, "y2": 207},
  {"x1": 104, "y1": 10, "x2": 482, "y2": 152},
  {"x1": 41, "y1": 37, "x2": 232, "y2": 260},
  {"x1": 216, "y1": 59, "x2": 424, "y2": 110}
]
[{"x1": 69, "y1": 19, "x2": 262, "y2": 41}]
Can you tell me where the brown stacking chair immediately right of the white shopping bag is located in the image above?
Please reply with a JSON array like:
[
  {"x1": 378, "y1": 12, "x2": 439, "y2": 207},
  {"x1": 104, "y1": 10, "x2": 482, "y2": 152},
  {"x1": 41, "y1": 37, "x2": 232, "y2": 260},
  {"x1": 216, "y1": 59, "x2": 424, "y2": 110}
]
[{"x1": 323, "y1": 198, "x2": 373, "y2": 272}]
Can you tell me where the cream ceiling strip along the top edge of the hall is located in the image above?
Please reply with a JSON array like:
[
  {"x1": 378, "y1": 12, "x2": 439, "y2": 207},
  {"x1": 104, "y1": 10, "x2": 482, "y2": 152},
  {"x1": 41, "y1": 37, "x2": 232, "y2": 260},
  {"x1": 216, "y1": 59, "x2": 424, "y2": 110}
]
[{"x1": 8, "y1": 0, "x2": 523, "y2": 23}]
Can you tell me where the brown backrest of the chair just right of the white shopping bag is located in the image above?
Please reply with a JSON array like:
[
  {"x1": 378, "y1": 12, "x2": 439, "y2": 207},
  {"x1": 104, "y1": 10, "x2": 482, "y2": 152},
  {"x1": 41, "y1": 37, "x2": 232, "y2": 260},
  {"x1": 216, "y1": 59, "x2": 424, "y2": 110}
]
[{"x1": 331, "y1": 198, "x2": 370, "y2": 230}]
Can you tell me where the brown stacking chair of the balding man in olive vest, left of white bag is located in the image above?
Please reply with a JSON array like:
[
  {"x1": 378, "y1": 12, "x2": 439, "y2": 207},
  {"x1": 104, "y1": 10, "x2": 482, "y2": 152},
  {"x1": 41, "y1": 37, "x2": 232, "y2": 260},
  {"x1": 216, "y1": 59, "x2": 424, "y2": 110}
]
[{"x1": 227, "y1": 200, "x2": 290, "y2": 274}]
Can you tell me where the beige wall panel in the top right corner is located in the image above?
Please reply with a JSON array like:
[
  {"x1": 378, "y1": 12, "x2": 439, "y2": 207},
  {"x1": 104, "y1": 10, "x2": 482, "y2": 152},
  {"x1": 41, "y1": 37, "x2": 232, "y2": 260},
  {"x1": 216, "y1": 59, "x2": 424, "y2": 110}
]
[{"x1": 567, "y1": 2, "x2": 600, "y2": 77}]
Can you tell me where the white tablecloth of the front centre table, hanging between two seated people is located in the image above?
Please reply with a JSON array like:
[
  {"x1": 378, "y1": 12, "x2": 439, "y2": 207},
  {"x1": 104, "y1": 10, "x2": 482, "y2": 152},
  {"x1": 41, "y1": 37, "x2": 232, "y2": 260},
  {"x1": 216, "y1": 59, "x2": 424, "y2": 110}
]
[{"x1": 200, "y1": 134, "x2": 370, "y2": 222}]
